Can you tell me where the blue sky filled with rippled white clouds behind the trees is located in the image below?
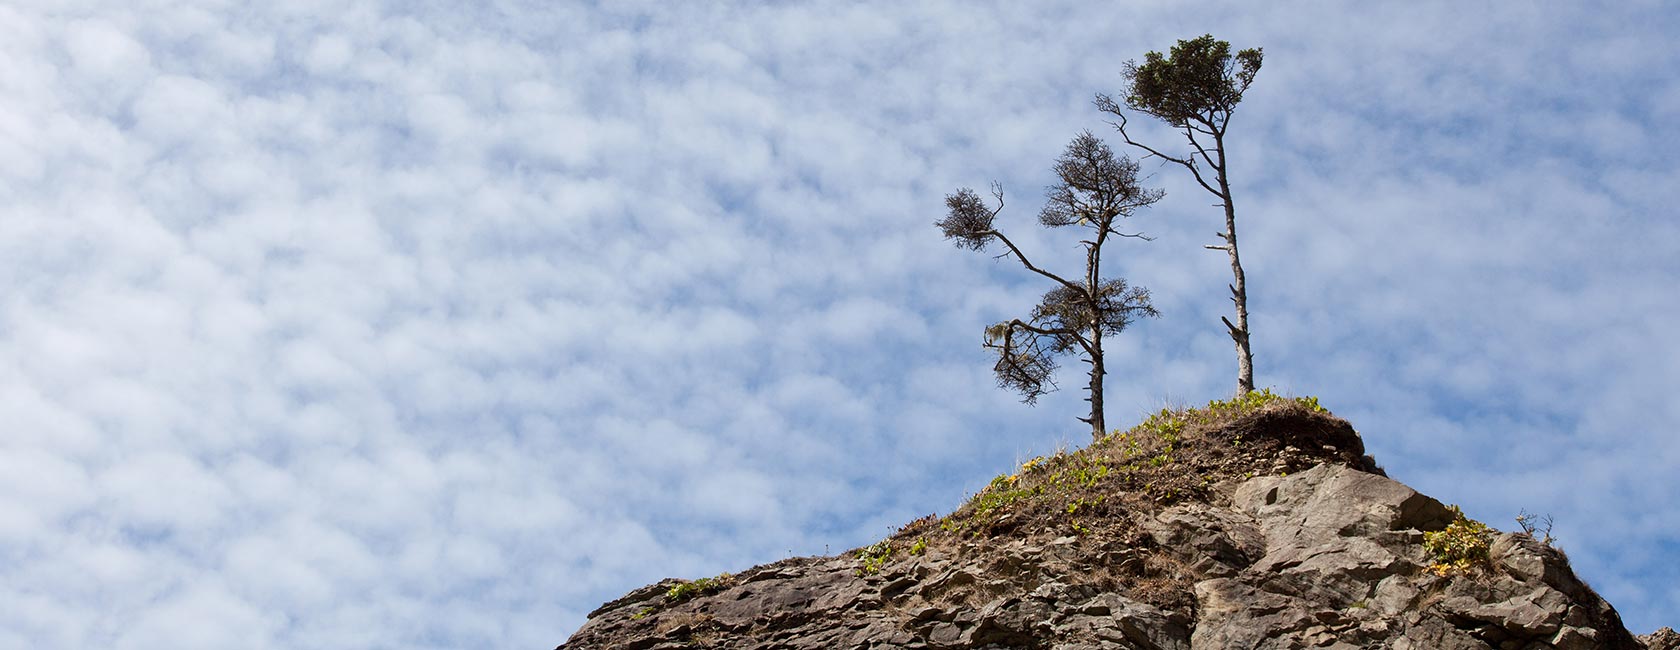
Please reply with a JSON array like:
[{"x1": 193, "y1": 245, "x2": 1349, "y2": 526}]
[{"x1": 0, "y1": 0, "x2": 1680, "y2": 650}]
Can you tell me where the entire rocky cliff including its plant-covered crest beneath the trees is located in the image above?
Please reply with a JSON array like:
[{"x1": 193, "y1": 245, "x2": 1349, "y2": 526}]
[{"x1": 559, "y1": 395, "x2": 1680, "y2": 650}]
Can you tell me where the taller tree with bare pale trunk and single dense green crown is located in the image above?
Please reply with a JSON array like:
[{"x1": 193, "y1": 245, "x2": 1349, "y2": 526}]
[{"x1": 1097, "y1": 35, "x2": 1260, "y2": 395}]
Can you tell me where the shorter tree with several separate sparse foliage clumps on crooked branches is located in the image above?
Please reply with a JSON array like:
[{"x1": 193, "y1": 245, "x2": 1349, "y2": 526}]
[{"x1": 934, "y1": 133, "x2": 1163, "y2": 438}]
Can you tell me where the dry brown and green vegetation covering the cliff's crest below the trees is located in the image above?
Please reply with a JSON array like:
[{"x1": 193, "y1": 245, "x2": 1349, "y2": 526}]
[{"x1": 873, "y1": 390, "x2": 1378, "y2": 606}]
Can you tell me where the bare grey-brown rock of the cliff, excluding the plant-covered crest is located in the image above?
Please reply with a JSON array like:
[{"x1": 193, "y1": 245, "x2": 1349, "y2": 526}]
[{"x1": 559, "y1": 409, "x2": 1653, "y2": 650}]
